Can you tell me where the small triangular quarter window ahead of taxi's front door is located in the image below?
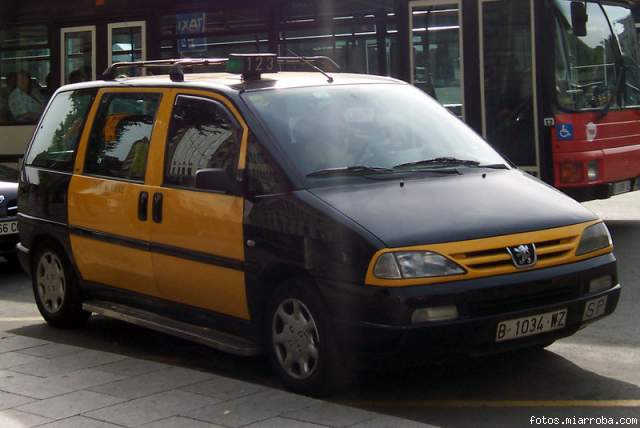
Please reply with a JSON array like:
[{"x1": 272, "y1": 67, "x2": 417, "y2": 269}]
[{"x1": 247, "y1": 136, "x2": 287, "y2": 195}]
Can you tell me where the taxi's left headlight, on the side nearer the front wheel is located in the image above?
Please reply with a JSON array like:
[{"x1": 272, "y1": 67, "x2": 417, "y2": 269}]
[{"x1": 373, "y1": 251, "x2": 465, "y2": 279}]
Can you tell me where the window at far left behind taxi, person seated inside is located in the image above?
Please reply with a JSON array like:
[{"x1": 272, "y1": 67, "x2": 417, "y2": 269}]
[{"x1": 0, "y1": 25, "x2": 53, "y2": 126}]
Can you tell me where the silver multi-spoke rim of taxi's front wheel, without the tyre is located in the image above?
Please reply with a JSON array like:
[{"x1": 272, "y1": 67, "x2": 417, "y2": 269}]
[{"x1": 271, "y1": 298, "x2": 320, "y2": 380}]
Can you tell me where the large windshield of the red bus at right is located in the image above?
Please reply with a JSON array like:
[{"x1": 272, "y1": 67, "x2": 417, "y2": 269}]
[{"x1": 555, "y1": 0, "x2": 640, "y2": 111}]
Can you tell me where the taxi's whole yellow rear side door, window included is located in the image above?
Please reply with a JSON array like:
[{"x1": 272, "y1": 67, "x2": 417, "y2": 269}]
[{"x1": 68, "y1": 87, "x2": 172, "y2": 296}]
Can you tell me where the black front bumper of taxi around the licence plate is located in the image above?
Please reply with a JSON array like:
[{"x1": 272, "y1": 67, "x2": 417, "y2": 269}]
[{"x1": 325, "y1": 254, "x2": 620, "y2": 365}]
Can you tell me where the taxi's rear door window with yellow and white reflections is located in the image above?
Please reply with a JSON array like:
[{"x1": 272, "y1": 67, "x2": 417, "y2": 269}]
[{"x1": 84, "y1": 93, "x2": 162, "y2": 181}]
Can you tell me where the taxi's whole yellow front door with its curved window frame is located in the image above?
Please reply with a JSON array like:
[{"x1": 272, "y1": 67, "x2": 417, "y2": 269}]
[{"x1": 148, "y1": 89, "x2": 249, "y2": 319}]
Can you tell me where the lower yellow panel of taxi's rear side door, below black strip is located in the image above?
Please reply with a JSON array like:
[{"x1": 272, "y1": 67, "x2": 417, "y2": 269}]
[{"x1": 71, "y1": 234, "x2": 157, "y2": 296}]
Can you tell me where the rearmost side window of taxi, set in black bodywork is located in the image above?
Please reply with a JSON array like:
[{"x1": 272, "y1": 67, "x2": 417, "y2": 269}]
[{"x1": 26, "y1": 89, "x2": 97, "y2": 172}]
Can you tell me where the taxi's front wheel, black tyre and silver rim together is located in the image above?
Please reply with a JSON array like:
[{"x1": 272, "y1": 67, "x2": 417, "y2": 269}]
[{"x1": 265, "y1": 280, "x2": 346, "y2": 396}]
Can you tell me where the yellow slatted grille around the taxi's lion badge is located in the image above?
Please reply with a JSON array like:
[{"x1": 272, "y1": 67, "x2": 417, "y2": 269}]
[{"x1": 451, "y1": 235, "x2": 579, "y2": 273}]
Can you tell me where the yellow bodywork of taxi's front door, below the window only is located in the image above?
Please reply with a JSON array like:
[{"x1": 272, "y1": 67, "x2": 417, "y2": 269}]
[{"x1": 152, "y1": 188, "x2": 248, "y2": 319}]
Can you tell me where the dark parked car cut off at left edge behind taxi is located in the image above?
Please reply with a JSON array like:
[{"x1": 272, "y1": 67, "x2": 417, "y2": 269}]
[{"x1": 0, "y1": 165, "x2": 18, "y2": 265}]
